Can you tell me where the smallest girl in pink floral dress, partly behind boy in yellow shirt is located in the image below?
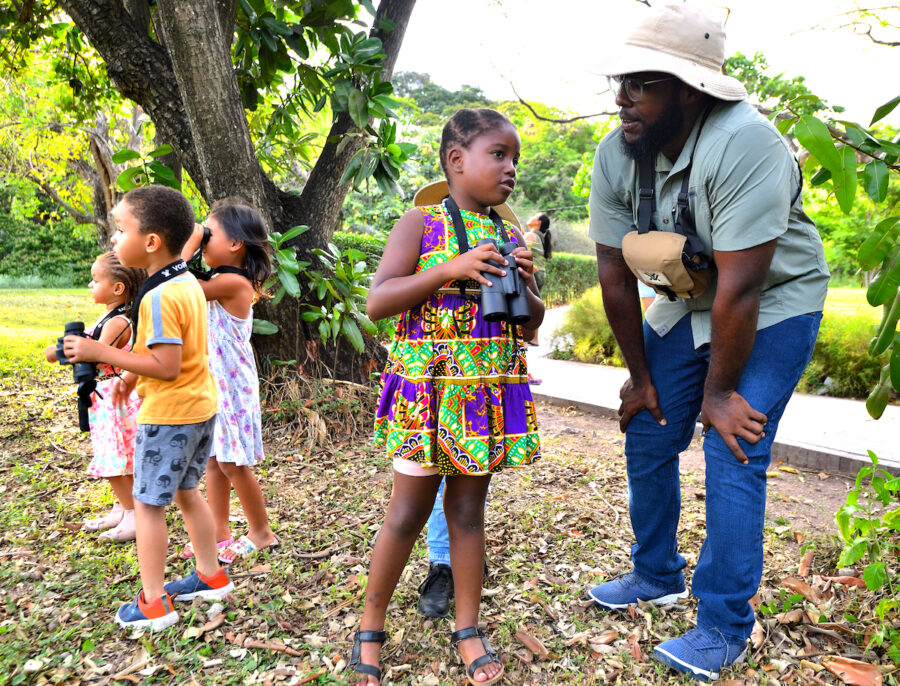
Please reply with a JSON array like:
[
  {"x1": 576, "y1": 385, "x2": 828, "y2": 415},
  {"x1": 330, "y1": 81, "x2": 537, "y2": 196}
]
[{"x1": 44, "y1": 252, "x2": 147, "y2": 543}]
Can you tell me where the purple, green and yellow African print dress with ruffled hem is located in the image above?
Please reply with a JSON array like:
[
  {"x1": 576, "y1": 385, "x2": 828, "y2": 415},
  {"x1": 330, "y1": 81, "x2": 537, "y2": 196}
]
[{"x1": 375, "y1": 205, "x2": 540, "y2": 476}]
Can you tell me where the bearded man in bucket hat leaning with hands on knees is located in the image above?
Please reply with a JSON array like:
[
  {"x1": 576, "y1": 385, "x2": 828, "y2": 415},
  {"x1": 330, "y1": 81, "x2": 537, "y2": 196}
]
[{"x1": 589, "y1": 5, "x2": 828, "y2": 681}]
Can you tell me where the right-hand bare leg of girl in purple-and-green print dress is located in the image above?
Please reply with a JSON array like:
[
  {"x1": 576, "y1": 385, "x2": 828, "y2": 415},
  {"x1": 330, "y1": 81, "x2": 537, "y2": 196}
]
[{"x1": 444, "y1": 475, "x2": 501, "y2": 681}]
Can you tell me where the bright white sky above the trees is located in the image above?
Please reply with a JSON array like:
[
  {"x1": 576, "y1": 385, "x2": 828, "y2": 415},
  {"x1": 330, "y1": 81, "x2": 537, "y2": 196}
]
[{"x1": 396, "y1": 0, "x2": 900, "y2": 125}]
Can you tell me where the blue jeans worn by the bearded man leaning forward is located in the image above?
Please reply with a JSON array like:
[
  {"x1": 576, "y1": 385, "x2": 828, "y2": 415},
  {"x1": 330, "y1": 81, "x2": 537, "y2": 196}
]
[{"x1": 625, "y1": 312, "x2": 822, "y2": 641}]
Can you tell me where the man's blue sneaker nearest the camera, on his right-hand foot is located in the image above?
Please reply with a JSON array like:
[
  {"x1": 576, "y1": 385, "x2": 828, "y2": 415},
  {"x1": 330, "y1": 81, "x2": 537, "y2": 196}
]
[{"x1": 653, "y1": 627, "x2": 747, "y2": 681}]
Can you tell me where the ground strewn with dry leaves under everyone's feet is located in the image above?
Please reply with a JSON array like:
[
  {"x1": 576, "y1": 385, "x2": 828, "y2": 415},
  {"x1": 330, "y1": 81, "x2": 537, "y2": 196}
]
[{"x1": 0, "y1": 372, "x2": 897, "y2": 686}]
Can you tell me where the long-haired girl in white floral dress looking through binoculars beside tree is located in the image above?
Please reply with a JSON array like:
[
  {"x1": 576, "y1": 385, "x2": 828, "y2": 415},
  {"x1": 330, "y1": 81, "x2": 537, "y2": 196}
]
[{"x1": 181, "y1": 201, "x2": 278, "y2": 564}]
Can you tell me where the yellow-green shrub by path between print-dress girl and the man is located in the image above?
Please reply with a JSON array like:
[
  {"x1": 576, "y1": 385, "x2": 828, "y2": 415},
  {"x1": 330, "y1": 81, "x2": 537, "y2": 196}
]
[{"x1": 550, "y1": 286, "x2": 625, "y2": 367}]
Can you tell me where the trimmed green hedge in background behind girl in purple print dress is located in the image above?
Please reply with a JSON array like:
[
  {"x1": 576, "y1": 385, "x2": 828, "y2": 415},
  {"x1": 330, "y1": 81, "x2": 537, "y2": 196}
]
[{"x1": 332, "y1": 231, "x2": 597, "y2": 307}]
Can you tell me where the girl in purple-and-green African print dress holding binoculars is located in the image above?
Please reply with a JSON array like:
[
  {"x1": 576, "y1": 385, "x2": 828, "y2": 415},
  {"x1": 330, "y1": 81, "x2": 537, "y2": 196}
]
[{"x1": 350, "y1": 109, "x2": 544, "y2": 686}]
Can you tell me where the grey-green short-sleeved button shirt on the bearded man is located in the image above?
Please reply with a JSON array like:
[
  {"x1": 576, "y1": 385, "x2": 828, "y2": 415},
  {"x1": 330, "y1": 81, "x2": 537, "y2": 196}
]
[{"x1": 589, "y1": 101, "x2": 829, "y2": 348}]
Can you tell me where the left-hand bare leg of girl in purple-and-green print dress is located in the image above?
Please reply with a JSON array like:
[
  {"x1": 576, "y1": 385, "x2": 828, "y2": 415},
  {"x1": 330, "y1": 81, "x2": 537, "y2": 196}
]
[{"x1": 354, "y1": 472, "x2": 444, "y2": 686}]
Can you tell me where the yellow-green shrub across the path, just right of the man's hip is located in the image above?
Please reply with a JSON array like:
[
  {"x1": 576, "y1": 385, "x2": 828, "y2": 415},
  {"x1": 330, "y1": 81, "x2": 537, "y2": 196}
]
[{"x1": 797, "y1": 311, "x2": 884, "y2": 398}]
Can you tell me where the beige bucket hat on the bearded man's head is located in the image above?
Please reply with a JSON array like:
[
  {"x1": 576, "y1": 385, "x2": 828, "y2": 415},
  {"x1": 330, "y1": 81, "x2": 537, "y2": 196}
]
[{"x1": 594, "y1": 5, "x2": 747, "y2": 100}]
